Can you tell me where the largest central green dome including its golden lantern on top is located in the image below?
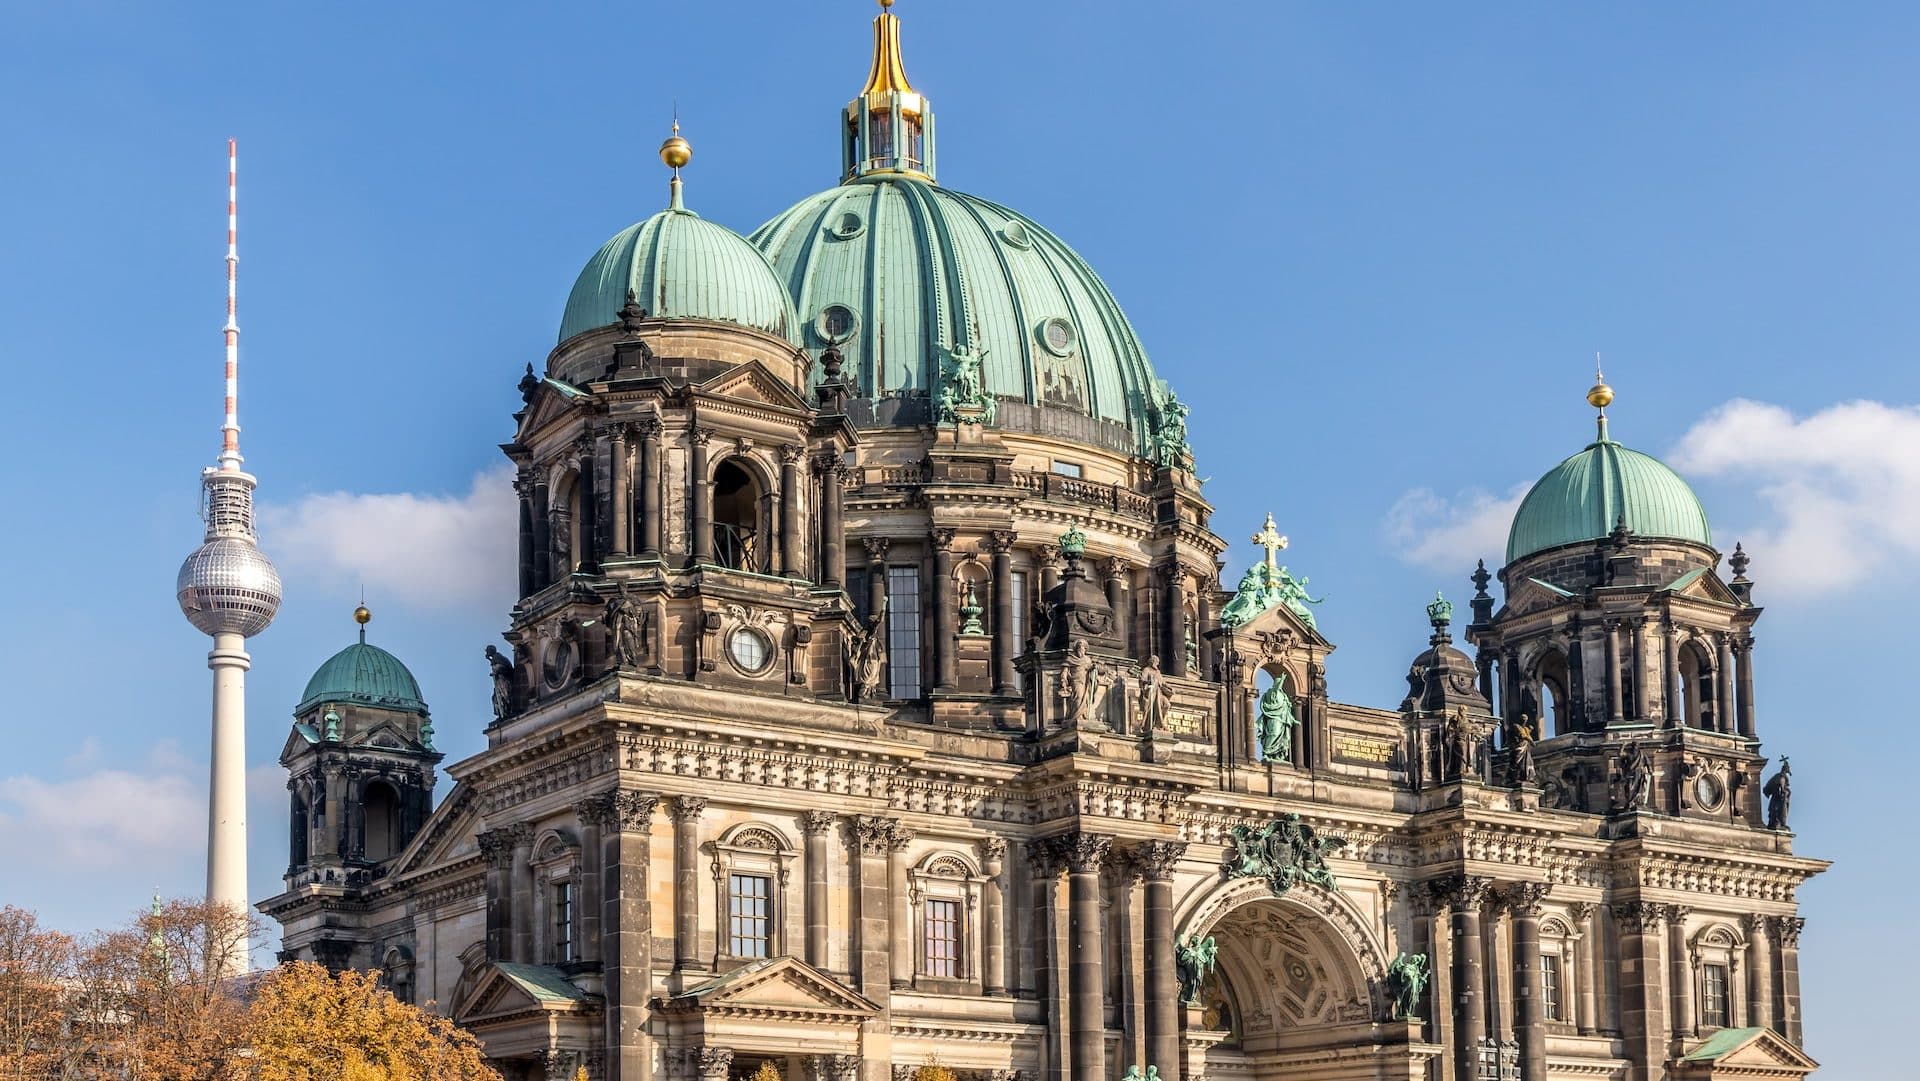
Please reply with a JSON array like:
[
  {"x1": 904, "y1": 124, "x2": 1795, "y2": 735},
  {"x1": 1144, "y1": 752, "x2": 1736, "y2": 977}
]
[{"x1": 751, "y1": 1, "x2": 1169, "y2": 453}]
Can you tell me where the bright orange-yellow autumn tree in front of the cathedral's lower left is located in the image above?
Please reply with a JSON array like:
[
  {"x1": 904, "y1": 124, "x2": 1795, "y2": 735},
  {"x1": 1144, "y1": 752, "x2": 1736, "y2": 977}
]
[{"x1": 248, "y1": 962, "x2": 499, "y2": 1081}]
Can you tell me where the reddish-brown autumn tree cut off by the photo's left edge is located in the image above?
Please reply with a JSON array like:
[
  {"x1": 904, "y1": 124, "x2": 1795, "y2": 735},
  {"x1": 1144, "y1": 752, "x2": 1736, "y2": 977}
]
[{"x1": 0, "y1": 904, "x2": 75, "y2": 1081}]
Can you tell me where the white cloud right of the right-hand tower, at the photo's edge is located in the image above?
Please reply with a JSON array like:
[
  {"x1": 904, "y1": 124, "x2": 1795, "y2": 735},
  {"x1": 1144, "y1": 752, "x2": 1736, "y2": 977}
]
[{"x1": 1670, "y1": 399, "x2": 1920, "y2": 591}]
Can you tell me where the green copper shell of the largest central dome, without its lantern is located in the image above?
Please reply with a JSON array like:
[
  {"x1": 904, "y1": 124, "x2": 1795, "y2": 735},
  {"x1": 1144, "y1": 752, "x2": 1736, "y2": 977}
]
[{"x1": 751, "y1": 173, "x2": 1158, "y2": 447}]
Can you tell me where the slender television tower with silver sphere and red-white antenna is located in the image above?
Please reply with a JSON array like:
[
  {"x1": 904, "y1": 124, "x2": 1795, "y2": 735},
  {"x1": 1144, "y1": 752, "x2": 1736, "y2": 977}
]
[{"x1": 177, "y1": 138, "x2": 280, "y2": 972}]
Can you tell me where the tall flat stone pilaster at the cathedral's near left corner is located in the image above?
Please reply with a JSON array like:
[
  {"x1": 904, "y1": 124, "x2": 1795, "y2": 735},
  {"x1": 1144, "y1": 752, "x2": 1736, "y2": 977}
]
[{"x1": 595, "y1": 789, "x2": 660, "y2": 1081}]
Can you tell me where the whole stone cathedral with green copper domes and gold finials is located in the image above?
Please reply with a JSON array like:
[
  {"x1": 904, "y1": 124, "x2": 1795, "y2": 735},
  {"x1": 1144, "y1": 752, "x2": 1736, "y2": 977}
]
[{"x1": 259, "y1": 2, "x2": 1828, "y2": 1081}]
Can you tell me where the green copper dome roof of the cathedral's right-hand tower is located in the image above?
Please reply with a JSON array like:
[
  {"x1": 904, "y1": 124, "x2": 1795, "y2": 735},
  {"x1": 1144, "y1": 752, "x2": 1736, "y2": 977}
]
[{"x1": 1507, "y1": 430, "x2": 1713, "y2": 563}]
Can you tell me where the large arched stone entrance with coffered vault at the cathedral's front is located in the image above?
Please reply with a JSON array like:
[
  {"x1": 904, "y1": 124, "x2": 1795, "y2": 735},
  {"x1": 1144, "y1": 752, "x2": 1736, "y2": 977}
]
[{"x1": 1183, "y1": 881, "x2": 1440, "y2": 1081}]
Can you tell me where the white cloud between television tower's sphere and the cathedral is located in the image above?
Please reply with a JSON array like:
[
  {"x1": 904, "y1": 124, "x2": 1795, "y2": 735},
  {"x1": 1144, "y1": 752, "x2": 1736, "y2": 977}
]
[{"x1": 261, "y1": 463, "x2": 518, "y2": 609}]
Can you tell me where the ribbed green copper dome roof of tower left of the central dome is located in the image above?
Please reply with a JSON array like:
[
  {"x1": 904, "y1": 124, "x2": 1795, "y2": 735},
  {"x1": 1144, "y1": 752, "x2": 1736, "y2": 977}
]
[{"x1": 561, "y1": 199, "x2": 799, "y2": 342}]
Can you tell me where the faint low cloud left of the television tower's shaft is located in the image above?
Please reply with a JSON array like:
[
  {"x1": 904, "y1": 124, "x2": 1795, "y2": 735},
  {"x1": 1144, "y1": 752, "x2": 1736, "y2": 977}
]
[{"x1": 0, "y1": 770, "x2": 207, "y2": 870}]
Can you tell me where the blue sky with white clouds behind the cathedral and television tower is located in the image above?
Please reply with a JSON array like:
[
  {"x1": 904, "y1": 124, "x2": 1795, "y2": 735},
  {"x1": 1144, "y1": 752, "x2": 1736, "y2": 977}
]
[{"x1": 0, "y1": 0, "x2": 1920, "y2": 1077}]
